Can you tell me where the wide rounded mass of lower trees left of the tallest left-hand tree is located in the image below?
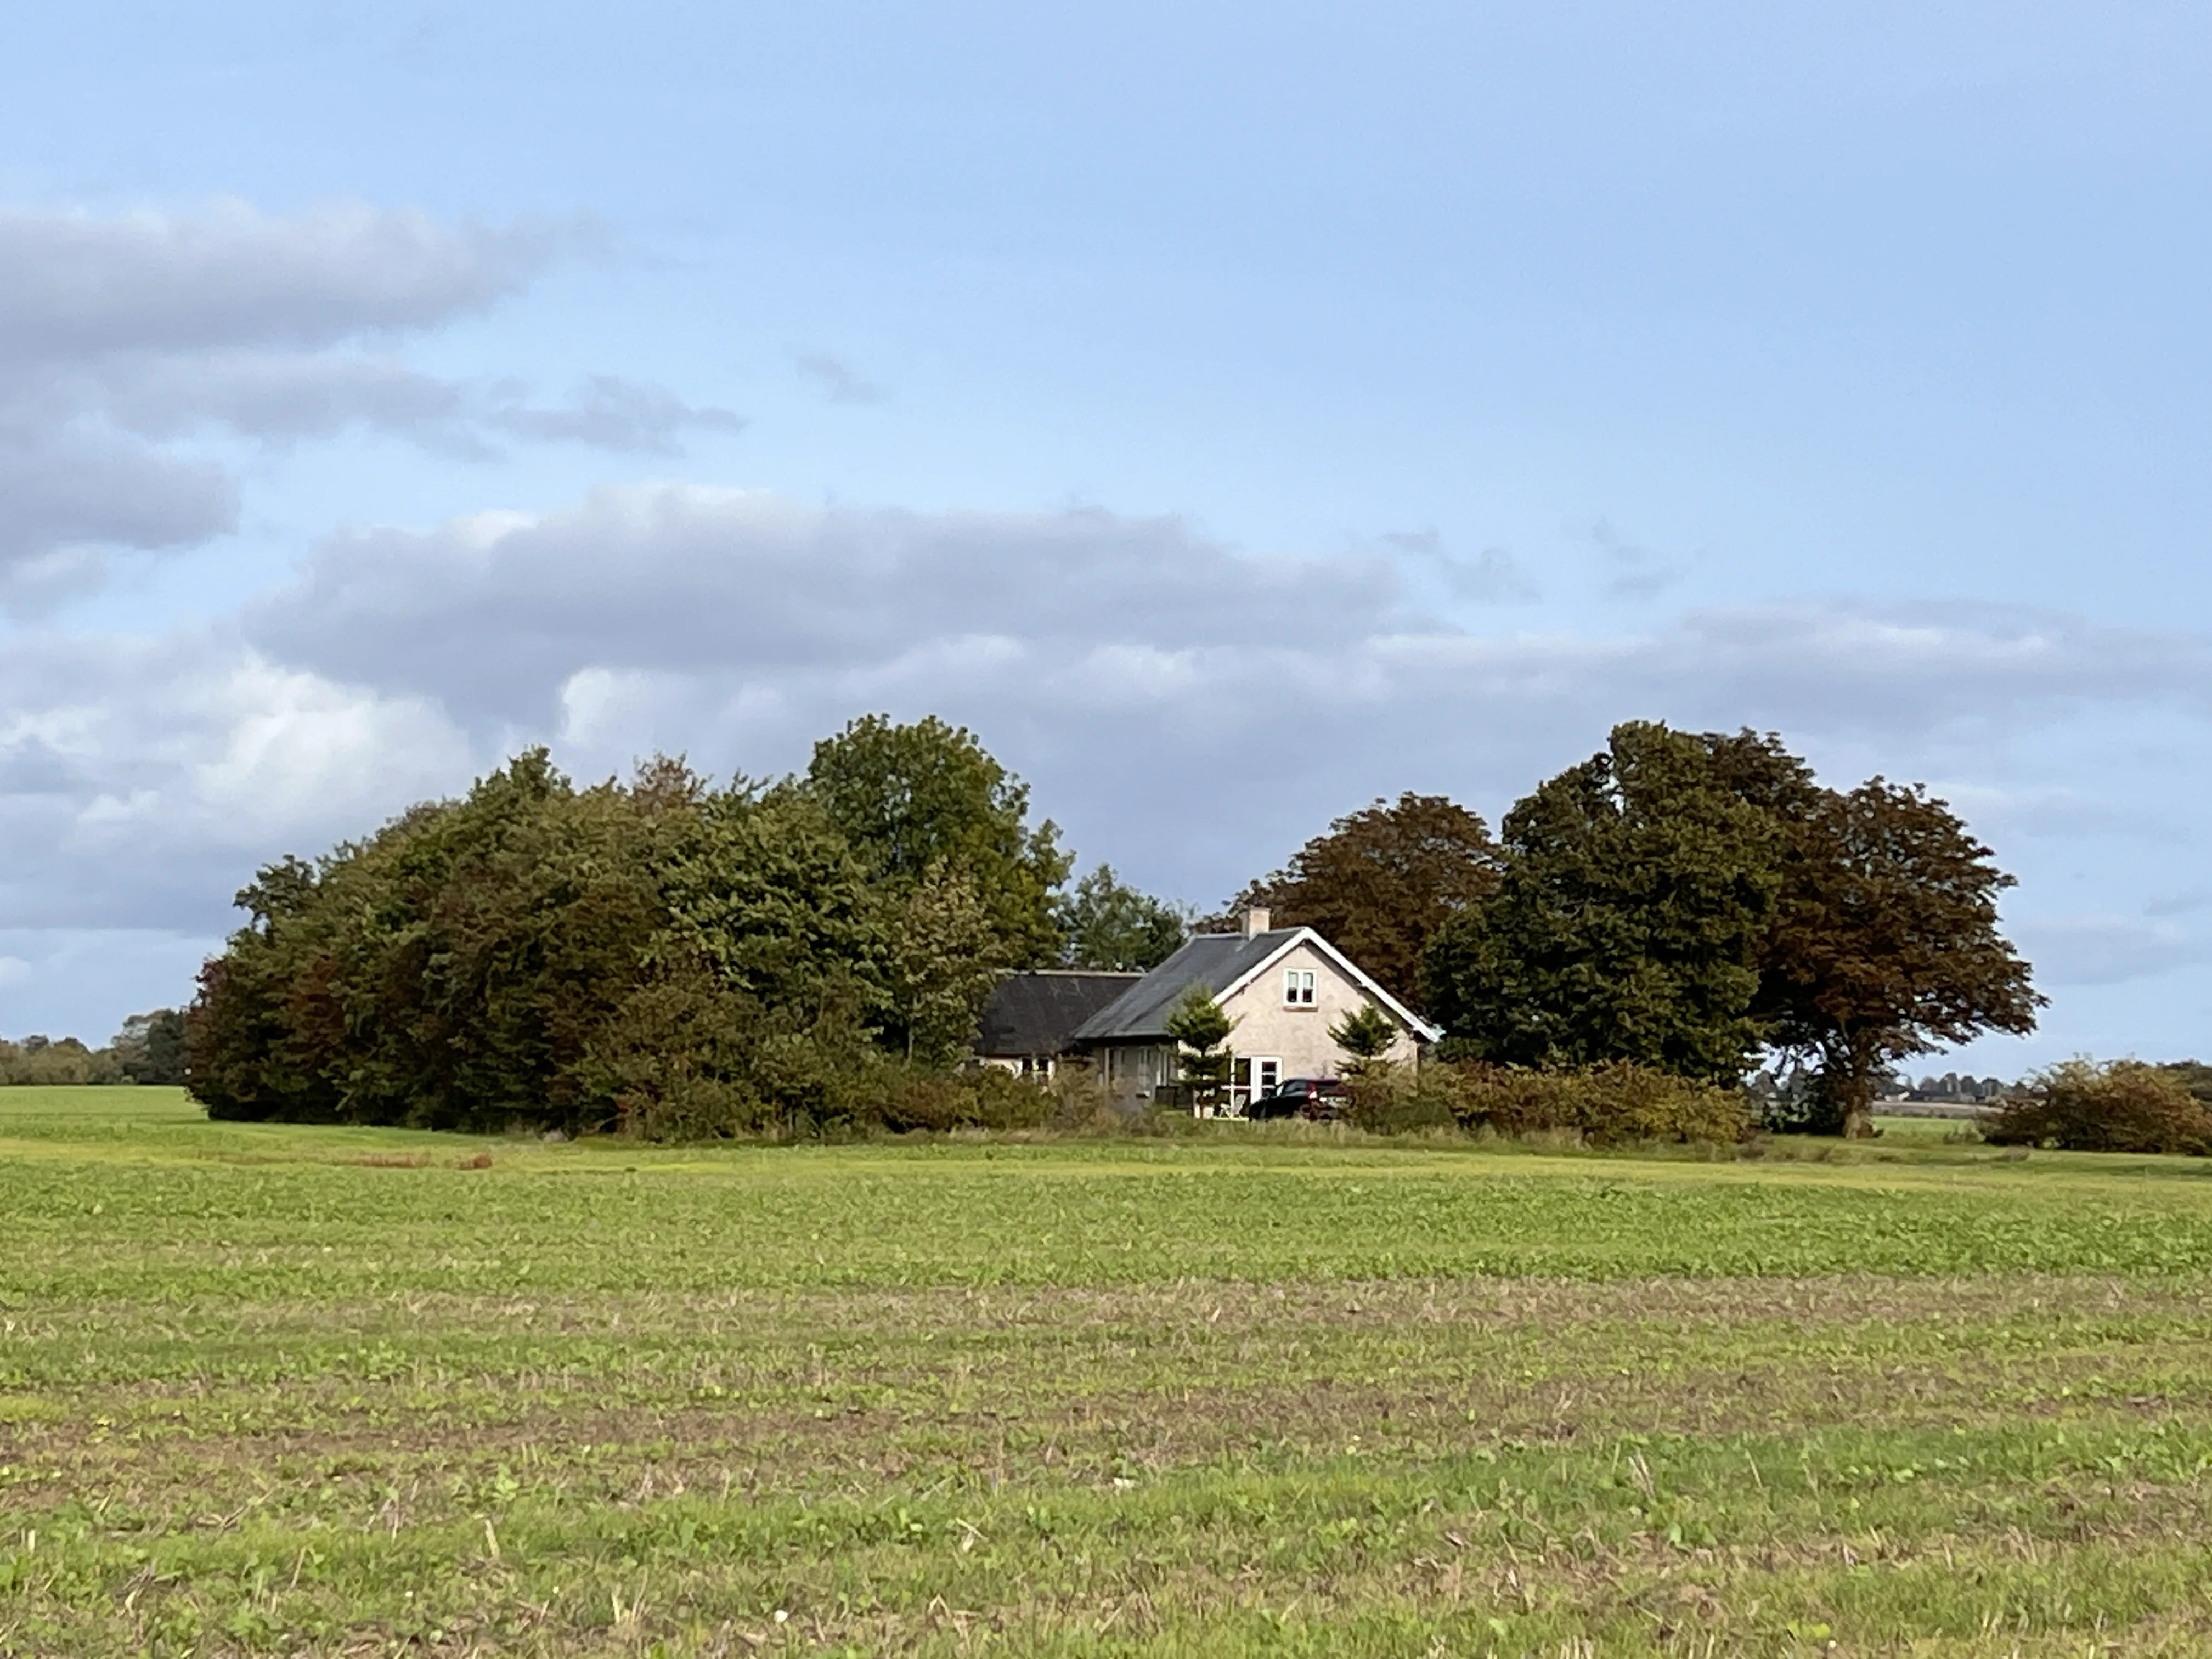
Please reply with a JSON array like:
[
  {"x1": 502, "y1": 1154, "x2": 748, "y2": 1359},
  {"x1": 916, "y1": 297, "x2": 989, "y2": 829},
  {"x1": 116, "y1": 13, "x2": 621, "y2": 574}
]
[{"x1": 186, "y1": 752, "x2": 889, "y2": 1132}]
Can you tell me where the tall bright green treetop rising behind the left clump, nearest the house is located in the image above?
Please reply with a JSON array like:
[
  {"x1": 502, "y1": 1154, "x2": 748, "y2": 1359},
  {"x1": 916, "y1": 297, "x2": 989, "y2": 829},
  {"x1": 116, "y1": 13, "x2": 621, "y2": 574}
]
[{"x1": 805, "y1": 714, "x2": 1070, "y2": 967}]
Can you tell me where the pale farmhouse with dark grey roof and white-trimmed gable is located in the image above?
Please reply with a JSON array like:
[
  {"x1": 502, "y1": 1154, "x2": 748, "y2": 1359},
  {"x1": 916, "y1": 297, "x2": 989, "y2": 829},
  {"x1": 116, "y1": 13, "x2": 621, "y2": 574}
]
[{"x1": 1075, "y1": 909, "x2": 1444, "y2": 1113}]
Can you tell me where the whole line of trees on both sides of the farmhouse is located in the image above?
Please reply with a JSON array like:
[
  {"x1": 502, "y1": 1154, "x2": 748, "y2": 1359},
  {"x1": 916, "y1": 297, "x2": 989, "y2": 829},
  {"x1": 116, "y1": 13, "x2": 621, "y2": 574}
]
[{"x1": 186, "y1": 716, "x2": 2040, "y2": 1135}]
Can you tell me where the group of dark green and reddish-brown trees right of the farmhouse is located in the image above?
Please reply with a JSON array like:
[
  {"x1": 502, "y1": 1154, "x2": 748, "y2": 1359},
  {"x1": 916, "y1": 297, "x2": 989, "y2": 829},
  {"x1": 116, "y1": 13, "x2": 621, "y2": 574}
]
[{"x1": 1234, "y1": 721, "x2": 2042, "y2": 1132}]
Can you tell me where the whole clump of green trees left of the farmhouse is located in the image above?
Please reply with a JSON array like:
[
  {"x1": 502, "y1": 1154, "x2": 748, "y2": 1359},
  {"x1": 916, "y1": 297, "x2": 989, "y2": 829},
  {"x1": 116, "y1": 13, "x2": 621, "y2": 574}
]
[{"x1": 188, "y1": 716, "x2": 1181, "y2": 1135}]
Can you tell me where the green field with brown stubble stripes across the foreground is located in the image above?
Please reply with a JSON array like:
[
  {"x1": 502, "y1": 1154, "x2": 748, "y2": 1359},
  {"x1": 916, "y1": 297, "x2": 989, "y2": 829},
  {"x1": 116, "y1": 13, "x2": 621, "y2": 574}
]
[{"x1": 0, "y1": 1088, "x2": 2212, "y2": 1657}]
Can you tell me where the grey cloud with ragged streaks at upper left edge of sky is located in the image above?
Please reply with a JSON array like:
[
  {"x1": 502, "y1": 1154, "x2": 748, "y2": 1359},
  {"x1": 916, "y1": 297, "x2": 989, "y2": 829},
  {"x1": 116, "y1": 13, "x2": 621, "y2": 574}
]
[{"x1": 0, "y1": 201, "x2": 743, "y2": 592}]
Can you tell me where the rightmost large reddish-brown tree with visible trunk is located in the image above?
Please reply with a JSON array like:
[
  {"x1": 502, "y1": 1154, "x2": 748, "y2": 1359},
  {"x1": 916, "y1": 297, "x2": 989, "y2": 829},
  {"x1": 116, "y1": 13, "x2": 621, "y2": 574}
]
[{"x1": 1752, "y1": 778, "x2": 2044, "y2": 1135}]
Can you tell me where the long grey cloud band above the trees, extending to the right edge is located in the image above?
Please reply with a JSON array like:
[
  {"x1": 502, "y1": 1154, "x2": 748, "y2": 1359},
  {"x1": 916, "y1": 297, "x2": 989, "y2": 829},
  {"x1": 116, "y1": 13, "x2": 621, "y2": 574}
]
[{"x1": 246, "y1": 487, "x2": 2212, "y2": 765}]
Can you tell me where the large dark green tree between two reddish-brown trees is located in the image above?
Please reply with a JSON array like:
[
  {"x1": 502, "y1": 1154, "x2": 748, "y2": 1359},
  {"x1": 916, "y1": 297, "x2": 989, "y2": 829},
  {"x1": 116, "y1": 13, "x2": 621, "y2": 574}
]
[{"x1": 1427, "y1": 721, "x2": 1781, "y2": 1084}]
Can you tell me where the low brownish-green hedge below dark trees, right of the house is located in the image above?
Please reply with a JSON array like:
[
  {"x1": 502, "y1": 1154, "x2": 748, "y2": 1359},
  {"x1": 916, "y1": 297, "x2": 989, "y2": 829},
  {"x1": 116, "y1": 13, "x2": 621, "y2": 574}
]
[{"x1": 1398, "y1": 1059, "x2": 1750, "y2": 1146}]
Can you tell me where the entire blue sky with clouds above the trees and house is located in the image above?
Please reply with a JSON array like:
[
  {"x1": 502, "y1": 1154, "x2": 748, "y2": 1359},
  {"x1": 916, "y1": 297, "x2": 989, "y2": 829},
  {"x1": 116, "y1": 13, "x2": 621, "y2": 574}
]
[{"x1": 0, "y1": 0, "x2": 2212, "y2": 1075}]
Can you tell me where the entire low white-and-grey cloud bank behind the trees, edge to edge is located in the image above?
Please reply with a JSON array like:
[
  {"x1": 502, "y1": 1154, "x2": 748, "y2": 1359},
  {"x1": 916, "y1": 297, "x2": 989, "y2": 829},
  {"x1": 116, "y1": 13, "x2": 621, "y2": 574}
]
[{"x1": 0, "y1": 484, "x2": 2212, "y2": 1026}]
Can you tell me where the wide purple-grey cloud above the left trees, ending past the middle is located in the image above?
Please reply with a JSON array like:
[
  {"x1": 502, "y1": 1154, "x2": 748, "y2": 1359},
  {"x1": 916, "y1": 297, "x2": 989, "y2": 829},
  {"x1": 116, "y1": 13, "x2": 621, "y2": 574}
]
[{"x1": 246, "y1": 487, "x2": 1398, "y2": 721}]
